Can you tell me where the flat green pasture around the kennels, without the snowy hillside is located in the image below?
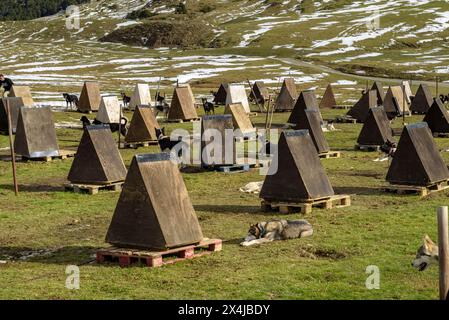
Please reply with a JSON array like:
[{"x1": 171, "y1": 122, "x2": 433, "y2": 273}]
[{"x1": 0, "y1": 105, "x2": 442, "y2": 299}]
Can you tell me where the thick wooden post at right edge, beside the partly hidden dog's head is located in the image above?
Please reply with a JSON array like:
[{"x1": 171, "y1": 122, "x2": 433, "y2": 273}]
[{"x1": 438, "y1": 207, "x2": 449, "y2": 300}]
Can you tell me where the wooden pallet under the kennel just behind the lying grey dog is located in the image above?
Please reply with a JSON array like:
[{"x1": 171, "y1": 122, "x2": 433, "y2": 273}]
[{"x1": 261, "y1": 195, "x2": 351, "y2": 214}]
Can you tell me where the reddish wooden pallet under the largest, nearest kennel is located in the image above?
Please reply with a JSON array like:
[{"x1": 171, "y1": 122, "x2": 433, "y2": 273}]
[{"x1": 97, "y1": 239, "x2": 222, "y2": 268}]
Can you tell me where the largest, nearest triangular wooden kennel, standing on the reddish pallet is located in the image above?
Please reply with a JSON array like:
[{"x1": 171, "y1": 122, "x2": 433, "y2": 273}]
[{"x1": 106, "y1": 153, "x2": 203, "y2": 249}]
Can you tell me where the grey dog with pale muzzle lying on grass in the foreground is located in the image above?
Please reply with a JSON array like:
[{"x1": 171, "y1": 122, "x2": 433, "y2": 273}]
[{"x1": 240, "y1": 219, "x2": 313, "y2": 247}]
